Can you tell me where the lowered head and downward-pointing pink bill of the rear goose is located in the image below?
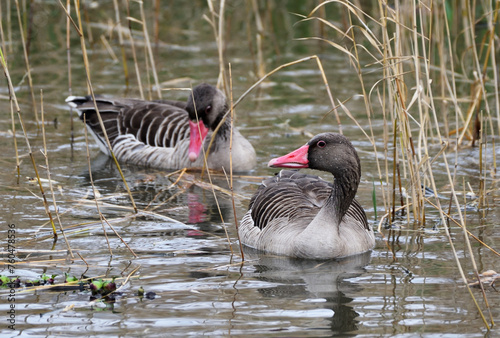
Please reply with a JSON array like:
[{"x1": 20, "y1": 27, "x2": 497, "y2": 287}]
[{"x1": 186, "y1": 83, "x2": 228, "y2": 162}]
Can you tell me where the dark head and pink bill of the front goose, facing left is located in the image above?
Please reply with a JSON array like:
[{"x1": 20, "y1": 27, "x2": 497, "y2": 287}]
[{"x1": 269, "y1": 133, "x2": 361, "y2": 187}]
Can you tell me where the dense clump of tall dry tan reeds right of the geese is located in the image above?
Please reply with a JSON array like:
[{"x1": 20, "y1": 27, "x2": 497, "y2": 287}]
[{"x1": 305, "y1": 0, "x2": 500, "y2": 327}]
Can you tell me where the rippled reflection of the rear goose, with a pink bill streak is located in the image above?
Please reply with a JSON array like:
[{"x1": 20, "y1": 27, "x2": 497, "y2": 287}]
[{"x1": 79, "y1": 153, "x2": 250, "y2": 231}]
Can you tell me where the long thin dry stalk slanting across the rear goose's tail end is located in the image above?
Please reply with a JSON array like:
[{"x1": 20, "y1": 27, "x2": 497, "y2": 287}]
[{"x1": 63, "y1": 0, "x2": 137, "y2": 212}]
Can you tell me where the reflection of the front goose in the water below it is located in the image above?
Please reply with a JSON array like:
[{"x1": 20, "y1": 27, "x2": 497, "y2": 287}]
[{"x1": 245, "y1": 248, "x2": 371, "y2": 334}]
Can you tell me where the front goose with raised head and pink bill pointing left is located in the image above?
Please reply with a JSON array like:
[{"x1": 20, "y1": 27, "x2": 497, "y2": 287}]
[{"x1": 238, "y1": 133, "x2": 375, "y2": 259}]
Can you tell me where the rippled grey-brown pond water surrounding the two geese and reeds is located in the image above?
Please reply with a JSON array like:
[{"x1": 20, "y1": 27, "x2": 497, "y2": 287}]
[{"x1": 0, "y1": 1, "x2": 500, "y2": 337}]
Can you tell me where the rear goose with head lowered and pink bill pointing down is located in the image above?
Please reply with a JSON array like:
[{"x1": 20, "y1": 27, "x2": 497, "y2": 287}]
[{"x1": 66, "y1": 83, "x2": 256, "y2": 171}]
